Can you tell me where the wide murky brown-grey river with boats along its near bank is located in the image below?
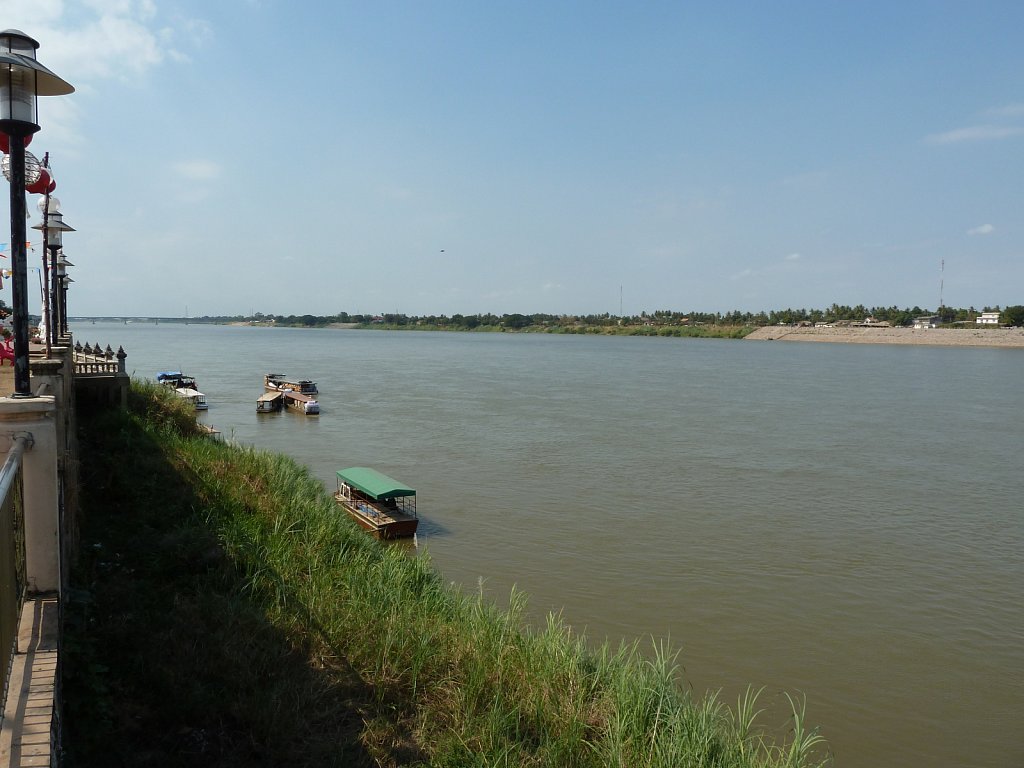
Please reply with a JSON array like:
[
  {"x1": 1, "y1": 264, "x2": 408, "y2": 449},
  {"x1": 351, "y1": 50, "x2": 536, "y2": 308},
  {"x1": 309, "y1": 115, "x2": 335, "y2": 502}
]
[{"x1": 73, "y1": 323, "x2": 1024, "y2": 768}]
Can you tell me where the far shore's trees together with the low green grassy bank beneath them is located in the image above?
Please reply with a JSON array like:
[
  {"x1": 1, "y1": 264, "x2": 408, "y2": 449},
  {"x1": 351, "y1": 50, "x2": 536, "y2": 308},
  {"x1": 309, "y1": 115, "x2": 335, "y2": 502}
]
[{"x1": 73, "y1": 304, "x2": 1024, "y2": 339}]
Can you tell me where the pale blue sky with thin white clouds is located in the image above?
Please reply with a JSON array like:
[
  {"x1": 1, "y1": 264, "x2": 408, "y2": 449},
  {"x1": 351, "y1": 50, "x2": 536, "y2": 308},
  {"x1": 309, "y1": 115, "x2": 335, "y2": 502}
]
[{"x1": 0, "y1": 0, "x2": 1024, "y2": 317}]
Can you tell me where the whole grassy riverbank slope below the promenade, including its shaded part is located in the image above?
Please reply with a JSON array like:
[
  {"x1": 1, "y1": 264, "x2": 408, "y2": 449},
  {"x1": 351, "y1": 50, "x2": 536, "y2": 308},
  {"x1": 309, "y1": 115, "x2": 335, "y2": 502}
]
[{"x1": 65, "y1": 384, "x2": 824, "y2": 768}]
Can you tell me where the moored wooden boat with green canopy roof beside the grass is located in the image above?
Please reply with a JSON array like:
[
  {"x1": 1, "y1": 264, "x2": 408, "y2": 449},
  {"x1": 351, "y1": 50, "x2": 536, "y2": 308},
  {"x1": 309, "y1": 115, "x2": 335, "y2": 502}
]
[{"x1": 334, "y1": 467, "x2": 420, "y2": 539}]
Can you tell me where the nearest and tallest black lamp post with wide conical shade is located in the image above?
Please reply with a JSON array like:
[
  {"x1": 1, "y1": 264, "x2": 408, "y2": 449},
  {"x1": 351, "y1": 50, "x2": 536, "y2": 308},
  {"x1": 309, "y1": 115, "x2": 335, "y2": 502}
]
[{"x1": 0, "y1": 30, "x2": 75, "y2": 397}]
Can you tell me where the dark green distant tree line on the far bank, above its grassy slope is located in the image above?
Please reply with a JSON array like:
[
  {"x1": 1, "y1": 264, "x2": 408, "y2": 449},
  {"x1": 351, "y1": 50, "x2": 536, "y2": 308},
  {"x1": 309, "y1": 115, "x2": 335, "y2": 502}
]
[{"x1": 180, "y1": 304, "x2": 1024, "y2": 333}]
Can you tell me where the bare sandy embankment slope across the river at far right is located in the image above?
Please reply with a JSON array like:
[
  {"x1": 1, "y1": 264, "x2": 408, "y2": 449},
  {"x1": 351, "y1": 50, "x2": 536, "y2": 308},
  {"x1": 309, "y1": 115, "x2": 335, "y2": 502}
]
[{"x1": 746, "y1": 326, "x2": 1024, "y2": 348}]
